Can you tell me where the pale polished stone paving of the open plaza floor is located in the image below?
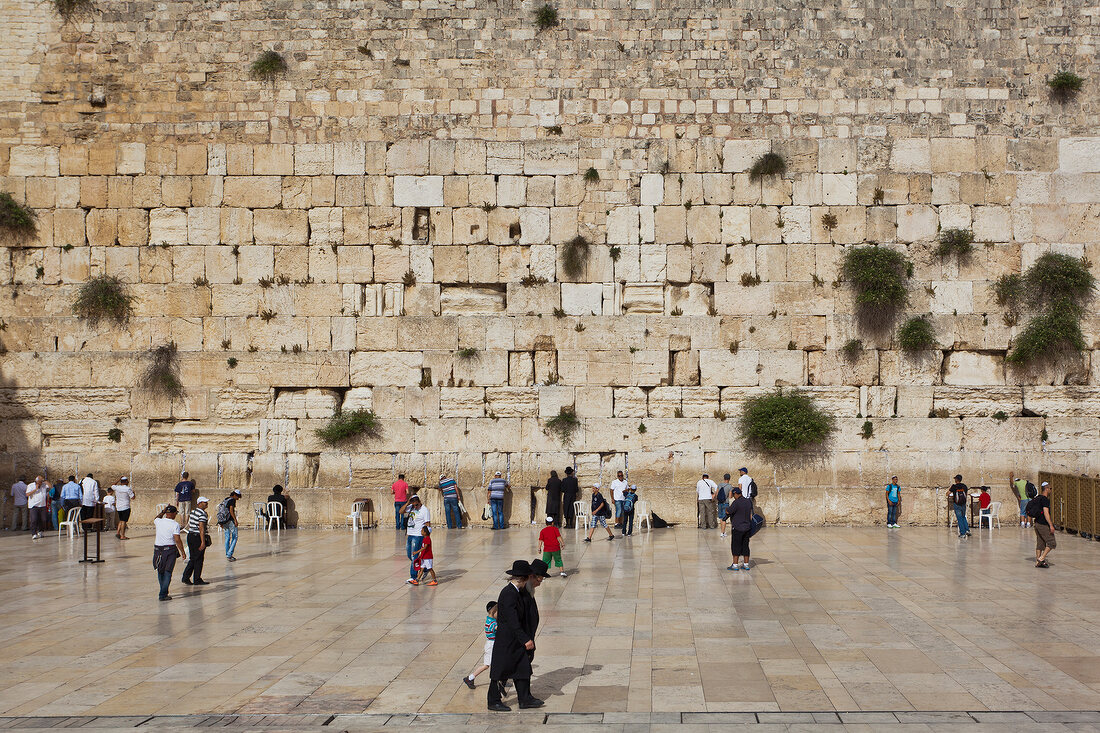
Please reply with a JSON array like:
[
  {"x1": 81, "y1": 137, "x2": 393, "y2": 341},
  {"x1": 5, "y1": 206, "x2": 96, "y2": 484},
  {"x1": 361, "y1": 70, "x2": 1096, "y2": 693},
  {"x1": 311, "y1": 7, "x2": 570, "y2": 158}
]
[{"x1": 0, "y1": 524, "x2": 1100, "y2": 732}]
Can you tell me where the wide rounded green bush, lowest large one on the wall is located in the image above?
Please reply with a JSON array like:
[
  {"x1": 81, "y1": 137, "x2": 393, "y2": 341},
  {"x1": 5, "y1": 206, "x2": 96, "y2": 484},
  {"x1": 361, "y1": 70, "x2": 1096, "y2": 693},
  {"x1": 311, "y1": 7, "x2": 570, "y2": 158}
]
[{"x1": 739, "y1": 390, "x2": 836, "y2": 452}]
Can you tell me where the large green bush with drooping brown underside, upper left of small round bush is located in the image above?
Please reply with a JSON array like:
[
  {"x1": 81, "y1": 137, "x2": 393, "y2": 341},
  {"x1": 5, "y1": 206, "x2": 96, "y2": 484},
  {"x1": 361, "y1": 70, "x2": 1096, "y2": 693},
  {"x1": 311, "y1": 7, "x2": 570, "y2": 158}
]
[{"x1": 840, "y1": 244, "x2": 910, "y2": 333}]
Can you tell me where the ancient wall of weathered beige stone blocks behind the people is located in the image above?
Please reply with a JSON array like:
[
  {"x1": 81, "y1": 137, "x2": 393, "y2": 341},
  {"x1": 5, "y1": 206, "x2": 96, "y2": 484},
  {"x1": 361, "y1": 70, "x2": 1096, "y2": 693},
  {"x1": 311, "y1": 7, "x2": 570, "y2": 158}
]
[{"x1": 0, "y1": 0, "x2": 1100, "y2": 524}]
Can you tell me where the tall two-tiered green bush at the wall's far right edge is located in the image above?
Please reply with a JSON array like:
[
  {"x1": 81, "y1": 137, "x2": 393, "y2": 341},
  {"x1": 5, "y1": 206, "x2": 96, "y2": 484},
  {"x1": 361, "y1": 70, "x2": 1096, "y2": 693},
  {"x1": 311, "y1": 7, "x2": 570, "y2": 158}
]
[{"x1": 1008, "y1": 252, "x2": 1096, "y2": 365}]
